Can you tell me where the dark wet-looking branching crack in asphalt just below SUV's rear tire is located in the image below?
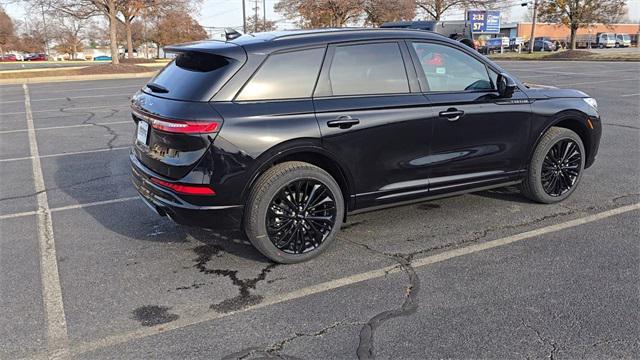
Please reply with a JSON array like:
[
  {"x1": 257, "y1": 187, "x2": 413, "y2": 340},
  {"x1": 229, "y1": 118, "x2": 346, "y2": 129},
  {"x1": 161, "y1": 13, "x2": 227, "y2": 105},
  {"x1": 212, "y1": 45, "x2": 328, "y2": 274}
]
[{"x1": 193, "y1": 245, "x2": 278, "y2": 313}]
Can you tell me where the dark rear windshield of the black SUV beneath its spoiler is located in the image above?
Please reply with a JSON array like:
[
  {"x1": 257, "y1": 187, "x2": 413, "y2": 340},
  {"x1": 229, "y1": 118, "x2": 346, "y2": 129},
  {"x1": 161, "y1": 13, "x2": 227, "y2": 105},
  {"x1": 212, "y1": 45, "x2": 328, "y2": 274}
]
[{"x1": 144, "y1": 52, "x2": 242, "y2": 101}]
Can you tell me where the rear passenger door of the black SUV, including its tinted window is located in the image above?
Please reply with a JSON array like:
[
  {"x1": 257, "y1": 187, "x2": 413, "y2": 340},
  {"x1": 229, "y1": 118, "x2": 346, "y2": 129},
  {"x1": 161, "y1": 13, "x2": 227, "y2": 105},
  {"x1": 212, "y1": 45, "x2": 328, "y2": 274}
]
[{"x1": 314, "y1": 41, "x2": 433, "y2": 208}]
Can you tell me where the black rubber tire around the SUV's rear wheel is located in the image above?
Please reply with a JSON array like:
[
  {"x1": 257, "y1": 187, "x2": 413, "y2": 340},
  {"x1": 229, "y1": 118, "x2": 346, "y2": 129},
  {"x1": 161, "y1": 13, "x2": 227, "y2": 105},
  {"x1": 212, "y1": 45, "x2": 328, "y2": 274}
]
[{"x1": 244, "y1": 161, "x2": 344, "y2": 264}]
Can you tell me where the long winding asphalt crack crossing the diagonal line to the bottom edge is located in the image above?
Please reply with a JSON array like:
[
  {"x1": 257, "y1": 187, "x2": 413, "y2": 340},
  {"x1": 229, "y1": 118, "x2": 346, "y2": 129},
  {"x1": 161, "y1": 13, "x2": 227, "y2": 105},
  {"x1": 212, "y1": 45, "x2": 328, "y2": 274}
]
[{"x1": 347, "y1": 240, "x2": 420, "y2": 360}]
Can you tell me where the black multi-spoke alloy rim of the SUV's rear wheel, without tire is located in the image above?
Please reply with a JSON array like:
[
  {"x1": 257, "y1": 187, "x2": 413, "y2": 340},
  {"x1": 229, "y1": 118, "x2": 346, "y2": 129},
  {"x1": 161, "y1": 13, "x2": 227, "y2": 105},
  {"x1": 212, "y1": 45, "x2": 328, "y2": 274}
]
[{"x1": 266, "y1": 179, "x2": 337, "y2": 254}]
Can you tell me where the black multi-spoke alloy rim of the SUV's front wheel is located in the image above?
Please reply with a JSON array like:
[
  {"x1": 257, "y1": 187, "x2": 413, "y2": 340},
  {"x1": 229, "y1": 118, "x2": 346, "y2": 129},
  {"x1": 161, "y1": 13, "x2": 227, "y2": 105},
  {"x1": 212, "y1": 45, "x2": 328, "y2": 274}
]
[{"x1": 542, "y1": 139, "x2": 582, "y2": 197}]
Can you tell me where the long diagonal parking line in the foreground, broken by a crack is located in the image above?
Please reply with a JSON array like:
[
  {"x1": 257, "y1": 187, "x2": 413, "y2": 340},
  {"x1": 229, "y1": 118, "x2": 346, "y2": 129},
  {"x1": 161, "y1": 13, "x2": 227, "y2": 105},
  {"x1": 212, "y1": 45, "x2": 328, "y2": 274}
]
[{"x1": 66, "y1": 203, "x2": 640, "y2": 356}]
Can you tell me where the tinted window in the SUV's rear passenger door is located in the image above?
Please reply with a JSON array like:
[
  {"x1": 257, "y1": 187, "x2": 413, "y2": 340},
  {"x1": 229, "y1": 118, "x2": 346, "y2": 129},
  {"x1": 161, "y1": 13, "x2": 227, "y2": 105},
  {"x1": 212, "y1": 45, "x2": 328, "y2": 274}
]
[{"x1": 329, "y1": 43, "x2": 409, "y2": 95}]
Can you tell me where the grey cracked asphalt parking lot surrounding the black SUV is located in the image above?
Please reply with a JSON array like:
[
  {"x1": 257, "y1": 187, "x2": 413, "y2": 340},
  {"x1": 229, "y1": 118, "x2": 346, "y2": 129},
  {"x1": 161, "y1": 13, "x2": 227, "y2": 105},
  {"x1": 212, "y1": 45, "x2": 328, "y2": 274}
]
[{"x1": 0, "y1": 61, "x2": 640, "y2": 359}]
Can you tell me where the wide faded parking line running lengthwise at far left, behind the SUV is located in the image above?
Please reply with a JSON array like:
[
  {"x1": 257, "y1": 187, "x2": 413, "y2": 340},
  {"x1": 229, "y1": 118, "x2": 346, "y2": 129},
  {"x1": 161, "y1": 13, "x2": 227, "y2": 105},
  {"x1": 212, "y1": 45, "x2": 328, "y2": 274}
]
[{"x1": 22, "y1": 84, "x2": 70, "y2": 359}]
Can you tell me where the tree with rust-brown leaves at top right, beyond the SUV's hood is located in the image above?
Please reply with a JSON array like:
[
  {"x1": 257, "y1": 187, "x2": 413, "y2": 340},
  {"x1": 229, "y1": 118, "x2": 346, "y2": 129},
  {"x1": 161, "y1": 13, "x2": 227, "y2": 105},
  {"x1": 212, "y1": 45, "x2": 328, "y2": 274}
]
[{"x1": 538, "y1": 0, "x2": 627, "y2": 50}]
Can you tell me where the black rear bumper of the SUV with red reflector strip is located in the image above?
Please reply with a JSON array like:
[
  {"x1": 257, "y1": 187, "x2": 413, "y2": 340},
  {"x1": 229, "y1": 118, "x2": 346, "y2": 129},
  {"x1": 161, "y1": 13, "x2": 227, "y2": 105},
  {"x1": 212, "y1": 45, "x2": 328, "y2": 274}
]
[{"x1": 129, "y1": 153, "x2": 243, "y2": 229}]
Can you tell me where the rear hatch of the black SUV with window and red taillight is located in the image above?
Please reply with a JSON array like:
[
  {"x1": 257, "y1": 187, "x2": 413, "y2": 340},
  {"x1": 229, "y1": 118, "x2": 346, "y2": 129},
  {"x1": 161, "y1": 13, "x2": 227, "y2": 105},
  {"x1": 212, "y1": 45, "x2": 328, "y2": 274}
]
[{"x1": 131, "y1": 41, "x2": 246, "y2": 182}]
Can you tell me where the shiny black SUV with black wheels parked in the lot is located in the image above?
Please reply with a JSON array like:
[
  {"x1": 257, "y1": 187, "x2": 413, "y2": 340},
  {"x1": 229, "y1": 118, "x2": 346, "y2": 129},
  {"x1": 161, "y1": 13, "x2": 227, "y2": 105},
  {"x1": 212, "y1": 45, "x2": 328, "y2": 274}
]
[{"x1": 130, "y1": 29, "x2": 601, "y2": 263}]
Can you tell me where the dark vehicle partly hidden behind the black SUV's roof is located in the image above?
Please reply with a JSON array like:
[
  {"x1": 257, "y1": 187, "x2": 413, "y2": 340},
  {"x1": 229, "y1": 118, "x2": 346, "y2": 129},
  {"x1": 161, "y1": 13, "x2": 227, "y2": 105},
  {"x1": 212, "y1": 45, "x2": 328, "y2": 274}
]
[{"x1": 380, "y1": 20, "x2": 478, "y2": 50}]
